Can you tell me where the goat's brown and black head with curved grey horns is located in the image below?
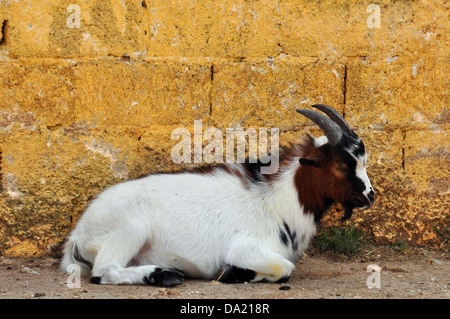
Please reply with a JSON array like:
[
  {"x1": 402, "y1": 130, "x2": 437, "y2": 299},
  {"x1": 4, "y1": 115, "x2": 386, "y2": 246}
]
[{"x1": 297, "y1": 104, "x2": 375, "y2": 220}]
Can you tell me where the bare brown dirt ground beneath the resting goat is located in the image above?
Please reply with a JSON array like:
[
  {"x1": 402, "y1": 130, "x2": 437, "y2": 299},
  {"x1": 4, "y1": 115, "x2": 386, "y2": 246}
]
[{"x1": 0, "y1": 247, "x2": 450, "y2": 299}]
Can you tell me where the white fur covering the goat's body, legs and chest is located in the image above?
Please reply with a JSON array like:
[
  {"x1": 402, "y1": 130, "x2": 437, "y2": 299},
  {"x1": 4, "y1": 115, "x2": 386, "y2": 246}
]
[{"x1": 61, "y1": 159, "x2": 315, "y2": 284}]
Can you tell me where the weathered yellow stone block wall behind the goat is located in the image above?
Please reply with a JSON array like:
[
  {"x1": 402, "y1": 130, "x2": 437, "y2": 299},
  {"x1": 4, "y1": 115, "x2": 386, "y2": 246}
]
[{"x1": 0, "y1": 0, "x2": 450, "y2": 256}]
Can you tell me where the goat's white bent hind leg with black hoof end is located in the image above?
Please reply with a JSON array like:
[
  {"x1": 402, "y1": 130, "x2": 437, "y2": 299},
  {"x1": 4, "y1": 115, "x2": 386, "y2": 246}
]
[{"x1": 91, "y1": 229, "x2": 183, "y2": 287}]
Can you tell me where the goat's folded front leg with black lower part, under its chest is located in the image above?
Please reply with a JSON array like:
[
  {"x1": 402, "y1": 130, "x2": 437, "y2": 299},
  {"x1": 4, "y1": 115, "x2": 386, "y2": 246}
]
[{"x1": 215, "y1": 253, "x2": 295, "y2": 283}]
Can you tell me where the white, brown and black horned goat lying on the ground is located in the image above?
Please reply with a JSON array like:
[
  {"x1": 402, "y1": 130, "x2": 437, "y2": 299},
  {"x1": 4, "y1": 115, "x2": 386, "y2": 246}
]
[{"x1": 61, "y1": 104, "x2": 375, "y2": 286}]
